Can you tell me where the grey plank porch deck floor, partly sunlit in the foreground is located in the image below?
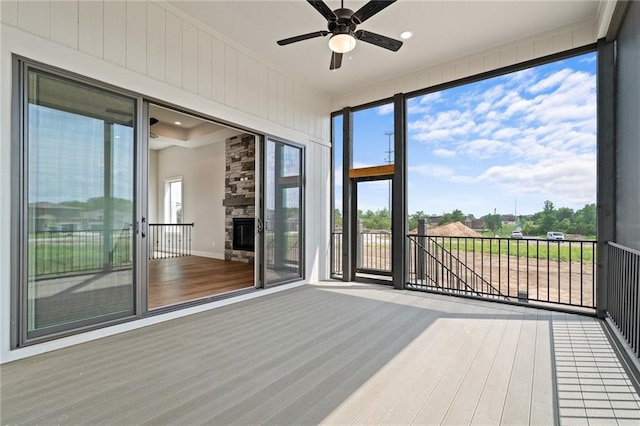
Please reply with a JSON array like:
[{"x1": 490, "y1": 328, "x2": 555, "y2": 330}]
[{"x1": 0, "y1": 283, "x2": 640, "y2": 425}]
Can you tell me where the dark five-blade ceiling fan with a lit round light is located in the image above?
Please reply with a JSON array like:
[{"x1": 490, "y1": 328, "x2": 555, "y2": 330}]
[{"x1": 277, "y1": 0, "x2": 402, "y2": 70}]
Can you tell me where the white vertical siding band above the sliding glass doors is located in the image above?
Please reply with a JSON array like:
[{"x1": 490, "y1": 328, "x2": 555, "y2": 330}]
[{"x1": 0, "y1": 0, "x2": 330, "y2": 142}]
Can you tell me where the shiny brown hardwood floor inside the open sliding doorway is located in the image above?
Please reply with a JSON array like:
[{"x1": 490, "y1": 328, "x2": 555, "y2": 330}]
[{"x1": 149, "y1": 256, "x2": 254, "y2": 309}]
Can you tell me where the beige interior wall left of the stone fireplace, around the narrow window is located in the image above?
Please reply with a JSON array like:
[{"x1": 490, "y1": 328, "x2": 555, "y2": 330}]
[{"x1": 157, "y1": 141, "x2": 225, "y2": 259}]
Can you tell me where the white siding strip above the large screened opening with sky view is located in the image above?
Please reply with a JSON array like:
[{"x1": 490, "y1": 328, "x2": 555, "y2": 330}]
[{"x1": 331, "y1": 21, "x2": 598, "y2": 111}]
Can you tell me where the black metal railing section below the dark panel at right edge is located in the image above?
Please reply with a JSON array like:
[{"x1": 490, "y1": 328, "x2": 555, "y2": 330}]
[{"x1": 607, "y1": 242, "x2": 640, "y2": 358}]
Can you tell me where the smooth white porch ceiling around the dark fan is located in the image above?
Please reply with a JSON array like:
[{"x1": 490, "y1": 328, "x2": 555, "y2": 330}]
[{"x1": 169, "y1": 0, "x2": 602, "y2": 95}]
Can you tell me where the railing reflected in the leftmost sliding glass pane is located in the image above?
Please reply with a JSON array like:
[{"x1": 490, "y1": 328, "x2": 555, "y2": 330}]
[{"x1": 28, "y1": 226, "x2": 133, "y2": 277}]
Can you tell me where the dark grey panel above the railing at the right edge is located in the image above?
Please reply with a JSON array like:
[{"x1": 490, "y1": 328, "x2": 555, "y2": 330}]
[{"x1": 616, "y1": 2, "x2": 640, "y2": 250}]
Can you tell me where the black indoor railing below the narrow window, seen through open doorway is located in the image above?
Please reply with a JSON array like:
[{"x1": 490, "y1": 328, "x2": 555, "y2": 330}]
[{"x1": 148, "y1": 223, "x2": 194, "y2": 259}]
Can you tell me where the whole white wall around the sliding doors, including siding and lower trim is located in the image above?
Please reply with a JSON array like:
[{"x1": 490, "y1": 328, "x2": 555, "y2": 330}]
[{"x1": 0, "y1": 0, "x2": 331, "y2": 363}]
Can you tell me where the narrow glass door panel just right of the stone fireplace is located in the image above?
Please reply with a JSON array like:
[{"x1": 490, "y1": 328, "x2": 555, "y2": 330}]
[{"x1": 263, "y1": 139, "x2": 303, "y2": 285}]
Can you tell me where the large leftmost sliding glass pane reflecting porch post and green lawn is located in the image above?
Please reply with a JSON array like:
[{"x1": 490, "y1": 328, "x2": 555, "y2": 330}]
[{"x1": 23, "y1": 70, "x2": 136, "y2": 338}]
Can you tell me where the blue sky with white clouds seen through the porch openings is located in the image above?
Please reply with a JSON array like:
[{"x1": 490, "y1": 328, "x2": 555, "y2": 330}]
[{"x1": 335, "y1": 53, "x2": 596, "y2": 217}]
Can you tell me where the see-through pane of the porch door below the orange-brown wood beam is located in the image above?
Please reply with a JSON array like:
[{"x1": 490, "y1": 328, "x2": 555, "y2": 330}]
[{"x1": 356, "y1": 179, "x2": 392, "y2": 279}]
